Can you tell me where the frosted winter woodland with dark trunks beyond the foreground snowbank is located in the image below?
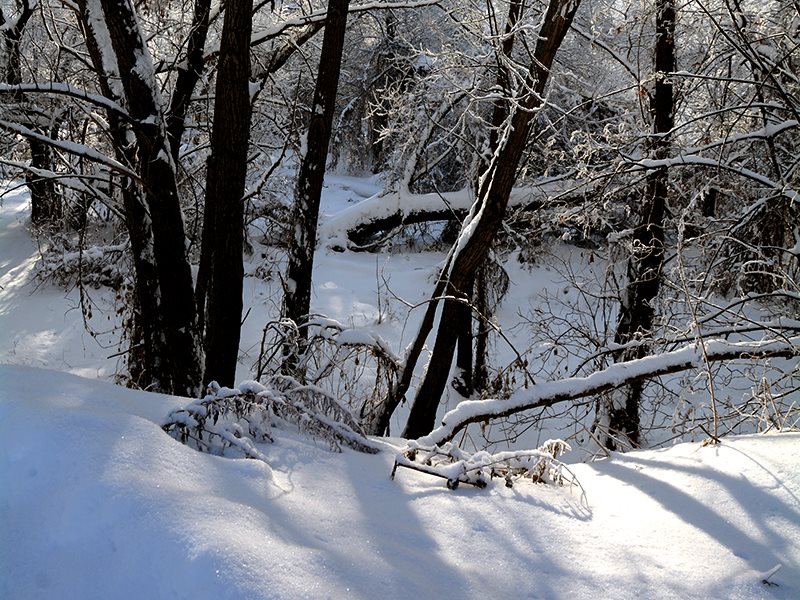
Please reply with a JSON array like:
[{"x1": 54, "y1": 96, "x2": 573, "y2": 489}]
[{"x1": 0, "y1": 0, "x2": 800, "y2": 598}]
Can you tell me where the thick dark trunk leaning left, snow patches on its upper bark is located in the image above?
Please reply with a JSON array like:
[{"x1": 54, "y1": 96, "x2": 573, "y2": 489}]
[{"x1": 79, "y1": 0, "x2": 202, "y2": 396}]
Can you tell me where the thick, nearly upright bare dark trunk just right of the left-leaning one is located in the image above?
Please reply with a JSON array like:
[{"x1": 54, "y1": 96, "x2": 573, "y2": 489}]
[{"x1": 199, "y1": 0, "x2": 253, "y2": 386}]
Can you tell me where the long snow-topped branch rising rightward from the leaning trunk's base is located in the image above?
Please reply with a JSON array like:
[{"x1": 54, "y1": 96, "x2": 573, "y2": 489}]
[{"x1": 417, "y1": 336, "x2": 800, "y2": 447}]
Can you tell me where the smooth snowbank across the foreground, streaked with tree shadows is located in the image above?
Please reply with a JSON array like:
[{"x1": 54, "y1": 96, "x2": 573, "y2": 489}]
[{"x1": 0, "y1": 366, "x2": 800, "y2": 599}]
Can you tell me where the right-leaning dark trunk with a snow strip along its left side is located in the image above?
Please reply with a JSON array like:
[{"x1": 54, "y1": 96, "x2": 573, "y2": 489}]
[{"x1": 401, "y1": 0, "x2": 580, "y2": 438}]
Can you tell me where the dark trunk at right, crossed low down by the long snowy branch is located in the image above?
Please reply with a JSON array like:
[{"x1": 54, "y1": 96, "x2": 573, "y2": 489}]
[{"x1": 606, "y1": 0, "x2": 675, "y2": 450}]
